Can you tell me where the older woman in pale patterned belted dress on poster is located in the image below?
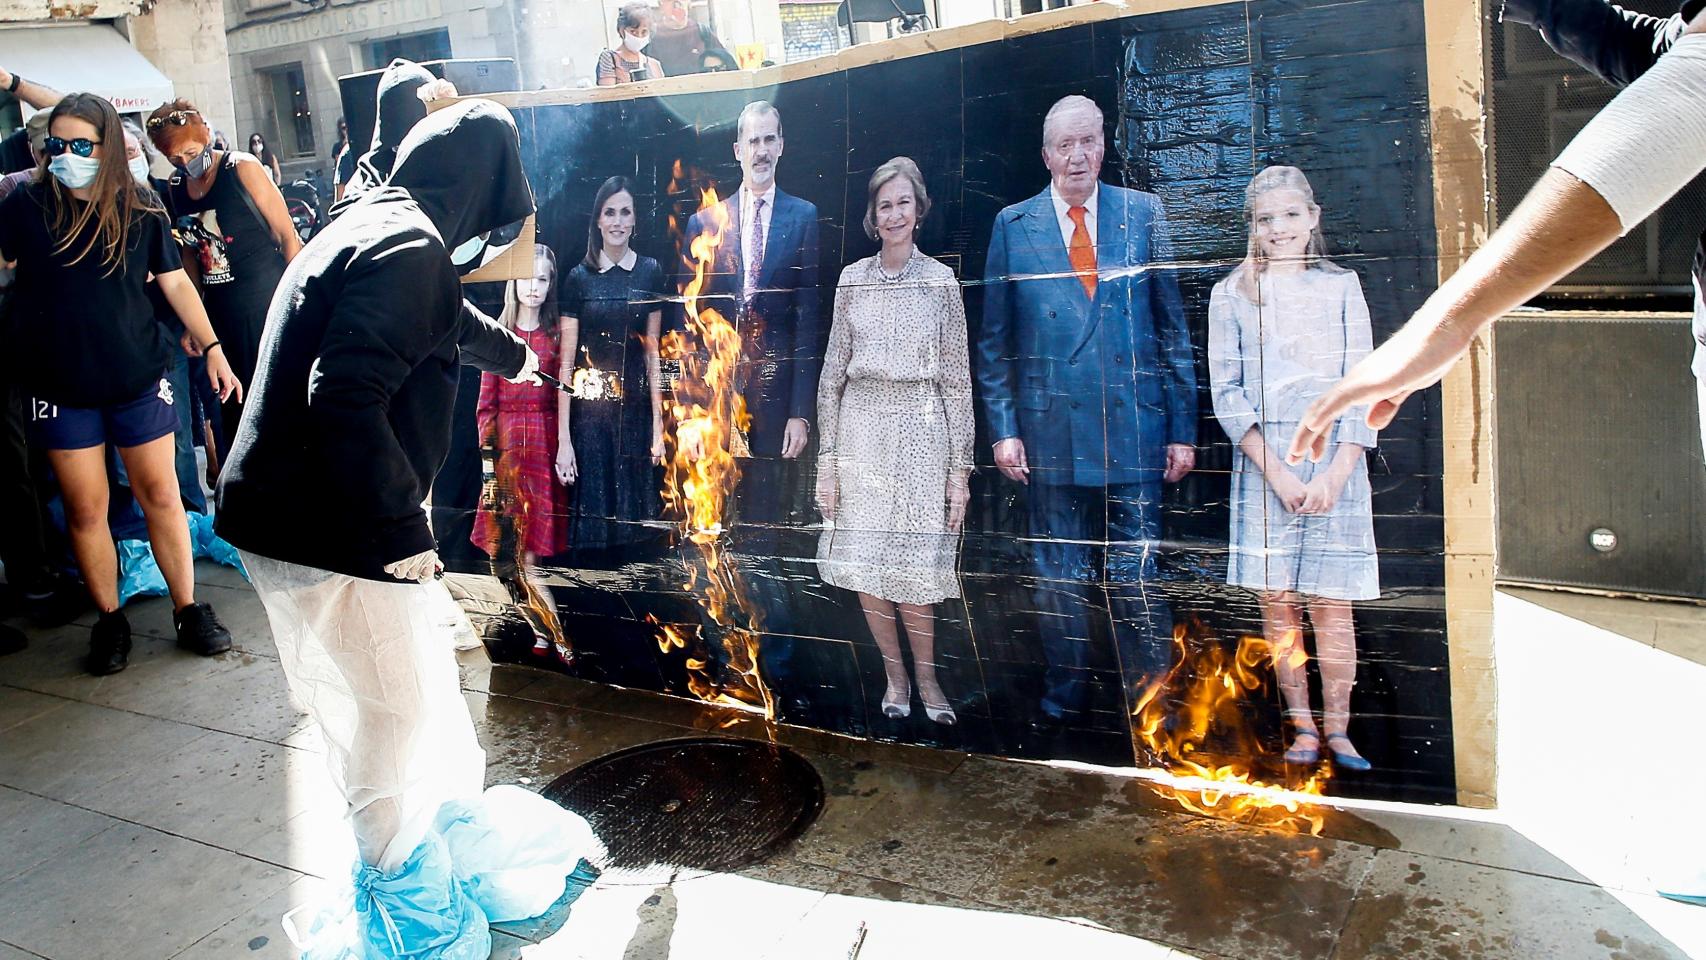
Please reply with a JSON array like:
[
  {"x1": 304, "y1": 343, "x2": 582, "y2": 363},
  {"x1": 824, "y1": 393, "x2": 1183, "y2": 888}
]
[{"x1": 817, "y1": 157, "x2": 972, "y2": 725}]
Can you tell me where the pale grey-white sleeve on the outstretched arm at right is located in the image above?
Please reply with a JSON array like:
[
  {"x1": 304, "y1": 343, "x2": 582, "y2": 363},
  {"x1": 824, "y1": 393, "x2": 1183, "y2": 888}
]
[{"x1": 1552, "y1": 34, "x2": 1706, "y2": 234}]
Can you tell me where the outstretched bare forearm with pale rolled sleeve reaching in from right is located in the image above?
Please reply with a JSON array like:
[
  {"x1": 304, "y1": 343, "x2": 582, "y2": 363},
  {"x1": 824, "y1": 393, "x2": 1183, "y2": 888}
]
[{"x1": 1288, "y1": 28, "x2": 1706, "y2": 462}]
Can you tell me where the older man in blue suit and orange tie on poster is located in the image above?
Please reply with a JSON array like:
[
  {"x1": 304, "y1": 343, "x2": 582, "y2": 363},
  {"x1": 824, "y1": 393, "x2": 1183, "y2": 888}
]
[{"x1": 978, "y1": 95, "x2": 1198, "y2": 725}]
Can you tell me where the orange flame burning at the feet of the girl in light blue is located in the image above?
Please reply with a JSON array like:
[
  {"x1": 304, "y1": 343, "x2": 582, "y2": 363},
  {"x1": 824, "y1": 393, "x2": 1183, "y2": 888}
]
[{"x1": 1131, "y1": 622, "x2": 1332, "y2": 836}]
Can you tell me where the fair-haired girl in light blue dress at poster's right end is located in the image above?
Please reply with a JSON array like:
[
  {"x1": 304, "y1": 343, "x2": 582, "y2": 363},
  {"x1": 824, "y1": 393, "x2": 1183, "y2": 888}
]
[{"x1": 1208, "y1": 167, "x2": 1380, "y2": 771}]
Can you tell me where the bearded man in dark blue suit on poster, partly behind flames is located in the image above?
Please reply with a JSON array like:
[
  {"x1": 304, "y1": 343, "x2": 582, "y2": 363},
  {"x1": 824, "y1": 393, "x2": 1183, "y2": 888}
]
[{"x1": 682, "y1": 101, "x2": 827, "y2": 554}]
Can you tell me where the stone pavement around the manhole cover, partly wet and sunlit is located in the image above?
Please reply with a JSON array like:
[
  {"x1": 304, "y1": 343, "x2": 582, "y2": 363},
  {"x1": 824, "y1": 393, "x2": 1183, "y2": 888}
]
[{"x1": 0, "y1": 566, "x2": 1706, "y2": 960}]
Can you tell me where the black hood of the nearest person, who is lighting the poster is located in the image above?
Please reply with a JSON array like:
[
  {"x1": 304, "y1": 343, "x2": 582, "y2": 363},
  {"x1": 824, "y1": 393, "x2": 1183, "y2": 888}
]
[{"x1": 387, "y1": 101, "x2": 534, "y2": 249}]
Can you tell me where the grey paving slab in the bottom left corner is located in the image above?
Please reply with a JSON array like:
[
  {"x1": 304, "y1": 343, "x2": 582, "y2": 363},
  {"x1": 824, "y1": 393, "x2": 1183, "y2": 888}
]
[{"x1": 0, "y1": 825, "x2": 295, "y2": 960}]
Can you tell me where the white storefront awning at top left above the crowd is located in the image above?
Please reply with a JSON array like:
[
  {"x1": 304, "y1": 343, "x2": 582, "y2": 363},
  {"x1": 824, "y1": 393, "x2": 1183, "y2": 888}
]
[{"x1": 0, "y1": 24, "x2": 172, "y2": 113}]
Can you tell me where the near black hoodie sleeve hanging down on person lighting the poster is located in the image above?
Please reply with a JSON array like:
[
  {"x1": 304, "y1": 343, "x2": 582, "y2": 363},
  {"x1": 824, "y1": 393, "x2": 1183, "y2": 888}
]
[{"x1": 307, "y1": 234, "x2": 452, "y2": 563}]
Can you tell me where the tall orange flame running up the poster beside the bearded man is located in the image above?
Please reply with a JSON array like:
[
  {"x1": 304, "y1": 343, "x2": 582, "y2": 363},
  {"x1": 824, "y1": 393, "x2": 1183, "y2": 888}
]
[{"x1": 659, "y1": 164, "x2": 776, "y2": 720}]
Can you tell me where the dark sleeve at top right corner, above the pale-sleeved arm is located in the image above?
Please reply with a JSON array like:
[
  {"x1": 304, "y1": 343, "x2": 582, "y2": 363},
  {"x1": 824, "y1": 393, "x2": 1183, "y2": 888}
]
[{"x1": 1503, "y1": 0, "x2": 1701, "y2": 87}]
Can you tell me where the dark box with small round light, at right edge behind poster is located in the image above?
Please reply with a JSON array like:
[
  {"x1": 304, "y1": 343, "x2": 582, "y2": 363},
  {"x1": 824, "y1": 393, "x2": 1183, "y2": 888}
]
[{"x1": 1494, "y1": 314, "x2": 1706, "y2": 599}]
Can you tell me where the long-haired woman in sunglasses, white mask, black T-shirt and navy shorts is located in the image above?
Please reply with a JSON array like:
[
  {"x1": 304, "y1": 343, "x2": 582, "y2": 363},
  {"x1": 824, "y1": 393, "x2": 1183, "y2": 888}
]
[{"x1": 0, "y1": 94, "x2": 242, "y2": 674}]
